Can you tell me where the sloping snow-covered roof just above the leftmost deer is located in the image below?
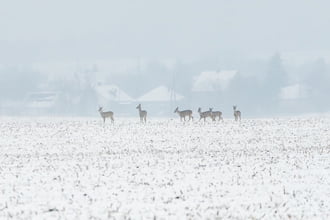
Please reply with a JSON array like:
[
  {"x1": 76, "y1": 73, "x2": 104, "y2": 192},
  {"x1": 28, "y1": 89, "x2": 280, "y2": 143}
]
[{"x1": 95, "y1": 84, "x2": 134, "y2": 102}]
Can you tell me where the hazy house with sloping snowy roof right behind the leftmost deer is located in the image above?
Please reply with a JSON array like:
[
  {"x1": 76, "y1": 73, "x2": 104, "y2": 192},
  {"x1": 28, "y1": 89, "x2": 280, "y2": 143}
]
[{"x1": 94, "y1": 83, "x2": 135, "y2": 115}]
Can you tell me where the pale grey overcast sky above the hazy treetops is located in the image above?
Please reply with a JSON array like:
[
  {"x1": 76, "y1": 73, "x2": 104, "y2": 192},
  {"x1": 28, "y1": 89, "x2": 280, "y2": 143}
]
[{"x1": 0, "y1": 0, "x2": 330, "y2": 64}]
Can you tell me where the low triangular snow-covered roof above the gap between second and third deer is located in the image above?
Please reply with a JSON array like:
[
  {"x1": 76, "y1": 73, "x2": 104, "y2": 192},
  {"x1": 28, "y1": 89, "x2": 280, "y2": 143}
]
[{"x1": 138, "y1": 86, "x2": 184, "y2": 102}]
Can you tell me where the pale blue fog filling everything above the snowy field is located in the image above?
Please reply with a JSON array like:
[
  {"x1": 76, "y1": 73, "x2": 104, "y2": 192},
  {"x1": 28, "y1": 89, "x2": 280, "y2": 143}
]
[{"x1": 0, "y1": 0, "x2": 330, "y2": 117}]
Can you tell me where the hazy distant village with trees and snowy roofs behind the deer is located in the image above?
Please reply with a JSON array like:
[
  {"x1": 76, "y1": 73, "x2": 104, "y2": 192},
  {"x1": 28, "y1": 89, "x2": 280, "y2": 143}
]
[{"x1": 0, "y1": 54, "x2": 330, "y2": 117}]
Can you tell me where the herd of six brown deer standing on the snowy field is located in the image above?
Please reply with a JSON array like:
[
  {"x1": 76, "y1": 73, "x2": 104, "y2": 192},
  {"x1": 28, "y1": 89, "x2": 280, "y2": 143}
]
[{"x1": 99, "y1": 104, "x2": 241, "y2": 123}]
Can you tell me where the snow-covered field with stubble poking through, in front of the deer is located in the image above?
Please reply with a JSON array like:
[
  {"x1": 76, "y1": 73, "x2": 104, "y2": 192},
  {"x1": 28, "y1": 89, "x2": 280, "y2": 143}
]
[{"x1": 0, "y1": 116, "x2": 330, "y2": 219}]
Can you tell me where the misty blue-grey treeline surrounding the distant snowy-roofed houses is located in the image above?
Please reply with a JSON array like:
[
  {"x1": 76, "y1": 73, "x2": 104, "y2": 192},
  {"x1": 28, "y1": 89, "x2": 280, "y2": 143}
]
[{"x1": 0, "y1": 53, "x2": 330, "y2": 116}]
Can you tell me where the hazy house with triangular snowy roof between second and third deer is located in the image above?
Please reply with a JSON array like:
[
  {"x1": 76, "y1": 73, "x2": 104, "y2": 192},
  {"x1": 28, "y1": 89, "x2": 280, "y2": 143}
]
[{"x1": 136, "y1": 86, "x2": 185, "y2": 116}]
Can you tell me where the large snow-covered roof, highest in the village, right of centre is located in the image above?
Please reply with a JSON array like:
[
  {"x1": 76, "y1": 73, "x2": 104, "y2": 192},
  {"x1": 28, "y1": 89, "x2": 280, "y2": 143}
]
[{"x1": 192, "y1": 70, "x2": 237, "y2": 92}]
